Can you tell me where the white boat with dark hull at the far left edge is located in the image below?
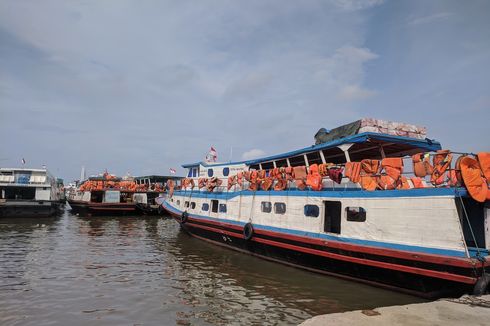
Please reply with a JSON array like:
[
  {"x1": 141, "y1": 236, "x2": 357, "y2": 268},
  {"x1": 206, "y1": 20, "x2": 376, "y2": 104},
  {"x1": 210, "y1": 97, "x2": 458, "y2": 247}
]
[{"x1": 0, "y1": 168, "x2": 63, "y2": 217}]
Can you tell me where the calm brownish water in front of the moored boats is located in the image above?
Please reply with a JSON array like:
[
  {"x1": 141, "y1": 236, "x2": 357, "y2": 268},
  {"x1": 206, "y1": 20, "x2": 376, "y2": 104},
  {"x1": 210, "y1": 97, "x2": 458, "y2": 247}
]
[{"x1": 0, "y1": 212, "x2": 420, "y2": 326}]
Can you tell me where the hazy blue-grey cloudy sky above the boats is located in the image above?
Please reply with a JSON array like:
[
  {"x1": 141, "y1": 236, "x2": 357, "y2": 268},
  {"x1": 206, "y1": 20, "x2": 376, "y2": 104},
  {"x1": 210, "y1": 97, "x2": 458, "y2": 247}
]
[{"x1": 0, "y1": 0, "x2": 490, "y2": 182}]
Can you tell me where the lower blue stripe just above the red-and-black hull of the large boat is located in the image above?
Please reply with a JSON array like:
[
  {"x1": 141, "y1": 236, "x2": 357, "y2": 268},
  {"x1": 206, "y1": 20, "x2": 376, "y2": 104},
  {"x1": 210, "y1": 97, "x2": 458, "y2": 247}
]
[{"x1": 163, "y1": 202, "x2": 467, "y2": 257}]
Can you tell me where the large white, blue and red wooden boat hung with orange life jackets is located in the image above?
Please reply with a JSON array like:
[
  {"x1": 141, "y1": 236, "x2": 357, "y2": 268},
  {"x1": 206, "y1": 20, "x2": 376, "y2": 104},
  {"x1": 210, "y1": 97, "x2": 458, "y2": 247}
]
[{"x1": 162, "y1": 119, "x2": 490, "y2": 297}]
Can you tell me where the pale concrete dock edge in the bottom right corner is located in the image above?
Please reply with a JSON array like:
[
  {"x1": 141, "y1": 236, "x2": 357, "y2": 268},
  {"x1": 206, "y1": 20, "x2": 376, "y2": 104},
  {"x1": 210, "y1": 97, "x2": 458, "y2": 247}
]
[{"x1": 301, "y1": 295, "x2": 490, "y2": 326}]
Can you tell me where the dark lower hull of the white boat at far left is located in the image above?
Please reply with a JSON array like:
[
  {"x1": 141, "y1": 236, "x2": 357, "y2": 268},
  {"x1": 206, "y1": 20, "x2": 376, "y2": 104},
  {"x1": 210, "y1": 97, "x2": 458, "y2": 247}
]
[{"x1": 0, "y1": 200, "x2": 62, "y2": 218}]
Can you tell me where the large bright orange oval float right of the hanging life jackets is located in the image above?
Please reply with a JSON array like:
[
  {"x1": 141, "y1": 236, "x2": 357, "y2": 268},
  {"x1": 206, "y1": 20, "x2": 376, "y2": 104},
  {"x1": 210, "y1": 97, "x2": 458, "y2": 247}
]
[{"x1": 461, "y1": 156, "x2": 488, "y2": 203}]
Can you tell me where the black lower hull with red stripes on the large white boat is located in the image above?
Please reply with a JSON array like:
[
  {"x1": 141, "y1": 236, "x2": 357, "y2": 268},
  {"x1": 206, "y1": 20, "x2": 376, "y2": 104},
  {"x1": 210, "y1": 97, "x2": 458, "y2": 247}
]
[{"x1": 167, "y1": 205, "x2": 489, "y2": 298}]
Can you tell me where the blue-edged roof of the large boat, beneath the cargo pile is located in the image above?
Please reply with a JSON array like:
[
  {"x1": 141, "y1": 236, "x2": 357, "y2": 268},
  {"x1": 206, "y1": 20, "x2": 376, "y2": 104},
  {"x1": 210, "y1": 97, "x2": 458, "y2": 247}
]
[{"x1": 182, "y1": 132, "x2": 441, "y2": 168}]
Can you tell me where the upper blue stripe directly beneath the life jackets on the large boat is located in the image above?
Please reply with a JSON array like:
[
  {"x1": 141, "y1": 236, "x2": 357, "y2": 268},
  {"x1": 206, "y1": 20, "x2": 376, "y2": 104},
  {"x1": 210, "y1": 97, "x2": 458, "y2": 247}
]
[{"x1": 174, "y1": 188, "x2": 467, "y2": 200}]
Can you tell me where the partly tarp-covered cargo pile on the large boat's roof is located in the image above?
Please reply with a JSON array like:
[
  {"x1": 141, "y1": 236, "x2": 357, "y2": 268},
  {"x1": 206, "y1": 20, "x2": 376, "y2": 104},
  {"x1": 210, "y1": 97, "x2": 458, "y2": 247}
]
[{"x1": 315, "y1": 118, "x2": 427, "y2": 145}]
